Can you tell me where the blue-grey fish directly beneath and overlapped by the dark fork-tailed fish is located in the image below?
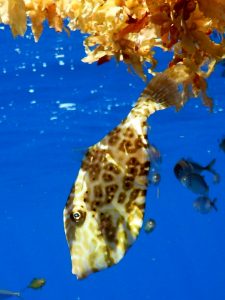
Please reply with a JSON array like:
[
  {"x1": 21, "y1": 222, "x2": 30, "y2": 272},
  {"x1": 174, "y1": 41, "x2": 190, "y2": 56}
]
[{"x1": 180, "y1": 173, "x2": 209, "y2": 195}]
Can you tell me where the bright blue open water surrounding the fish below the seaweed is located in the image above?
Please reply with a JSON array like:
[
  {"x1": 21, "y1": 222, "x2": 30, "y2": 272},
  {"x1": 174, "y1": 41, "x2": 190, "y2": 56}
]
[{"x1": 0, "y1": 26, "x2": 225, "y2": 300}]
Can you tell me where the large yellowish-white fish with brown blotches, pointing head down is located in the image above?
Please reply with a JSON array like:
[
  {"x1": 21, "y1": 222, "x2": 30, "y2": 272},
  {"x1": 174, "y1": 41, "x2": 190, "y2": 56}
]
[{"x1": 64, "y1": 74, "x2": 181, "y2": 278}]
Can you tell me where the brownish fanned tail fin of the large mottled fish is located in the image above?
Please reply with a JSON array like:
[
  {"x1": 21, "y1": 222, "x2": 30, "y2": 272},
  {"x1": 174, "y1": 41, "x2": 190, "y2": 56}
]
[{"x1": 141, "y1": 73, "x2": 183, "y2": 110}]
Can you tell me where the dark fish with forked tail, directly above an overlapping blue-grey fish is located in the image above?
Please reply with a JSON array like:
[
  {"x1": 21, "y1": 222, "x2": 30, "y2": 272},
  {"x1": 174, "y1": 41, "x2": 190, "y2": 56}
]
[{"x1": 174, "y1": 159, "x2": 219, "y2": 183}]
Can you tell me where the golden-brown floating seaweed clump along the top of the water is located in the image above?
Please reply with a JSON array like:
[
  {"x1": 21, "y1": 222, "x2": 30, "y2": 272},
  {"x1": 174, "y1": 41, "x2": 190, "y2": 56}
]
[{"x1": 0, "y1": 0, "x2": 225, "y2": 108}]
